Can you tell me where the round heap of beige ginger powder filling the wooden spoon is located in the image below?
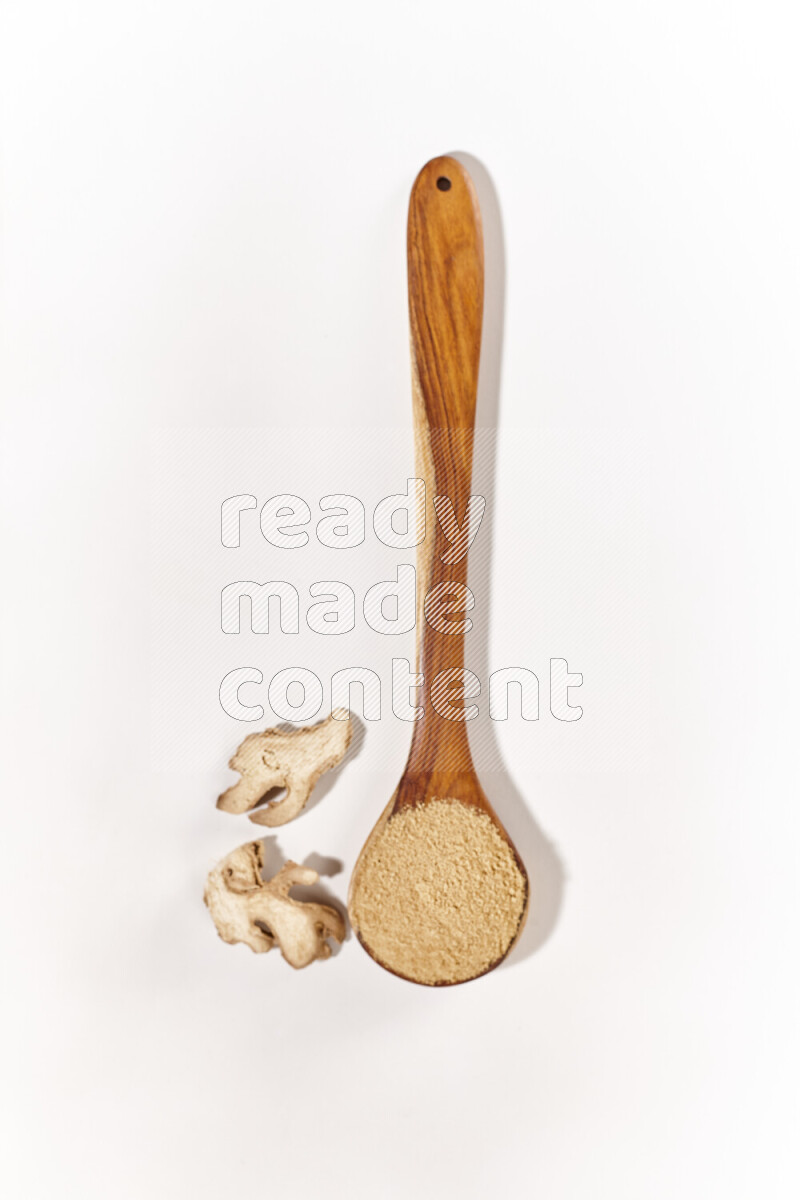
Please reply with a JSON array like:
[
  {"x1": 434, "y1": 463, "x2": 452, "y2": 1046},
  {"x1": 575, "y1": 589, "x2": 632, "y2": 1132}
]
[{"x1": 350, "y1": 799, "x2": 527, "y2": 984}]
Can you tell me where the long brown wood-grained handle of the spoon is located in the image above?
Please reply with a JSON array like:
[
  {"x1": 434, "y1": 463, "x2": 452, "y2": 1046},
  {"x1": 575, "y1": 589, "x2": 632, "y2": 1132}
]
[{"x1": 397, "y1": 156, "x2": 483, "y2": 787}]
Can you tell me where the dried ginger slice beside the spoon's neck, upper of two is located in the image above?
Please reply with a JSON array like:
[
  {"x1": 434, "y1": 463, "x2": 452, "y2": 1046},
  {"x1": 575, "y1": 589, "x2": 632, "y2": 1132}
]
[{"x1": 217, "y1": 708, "x2": 353, "y2": 826}]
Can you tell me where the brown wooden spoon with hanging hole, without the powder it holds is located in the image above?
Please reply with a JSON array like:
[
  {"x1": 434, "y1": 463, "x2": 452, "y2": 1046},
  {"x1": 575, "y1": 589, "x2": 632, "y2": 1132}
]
[{"x1": 349, "y1": 157, "x2": 529, "y2": 983}]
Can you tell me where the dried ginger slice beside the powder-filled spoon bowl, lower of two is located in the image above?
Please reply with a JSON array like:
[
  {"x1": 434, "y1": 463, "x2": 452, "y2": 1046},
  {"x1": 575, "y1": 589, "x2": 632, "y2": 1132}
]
[{"x1": 203, "y1": 841, "x2": 344, "y2": 968}]
